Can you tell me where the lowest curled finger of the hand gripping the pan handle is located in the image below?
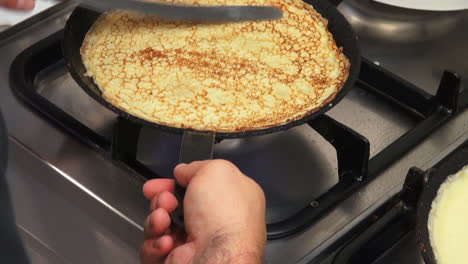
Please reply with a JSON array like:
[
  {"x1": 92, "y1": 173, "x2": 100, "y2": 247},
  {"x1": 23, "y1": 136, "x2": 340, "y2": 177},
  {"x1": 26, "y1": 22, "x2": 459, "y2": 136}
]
[{"x1": 140, "y1": 235, "x2": 174, "y2": 264}]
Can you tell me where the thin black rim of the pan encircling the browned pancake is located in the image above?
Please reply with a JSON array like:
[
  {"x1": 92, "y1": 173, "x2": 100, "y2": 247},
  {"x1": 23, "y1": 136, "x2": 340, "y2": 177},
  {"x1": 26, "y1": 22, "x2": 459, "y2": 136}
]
[{"x1": 62, "y1": 0, "x2": 361, "y2": 139}]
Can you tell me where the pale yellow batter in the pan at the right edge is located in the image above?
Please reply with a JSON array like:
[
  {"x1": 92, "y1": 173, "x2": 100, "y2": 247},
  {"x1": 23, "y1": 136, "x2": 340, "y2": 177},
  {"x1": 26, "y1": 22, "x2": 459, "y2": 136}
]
[{"x1": 428, "y1": 166, "x2": 468, "y2": 264}]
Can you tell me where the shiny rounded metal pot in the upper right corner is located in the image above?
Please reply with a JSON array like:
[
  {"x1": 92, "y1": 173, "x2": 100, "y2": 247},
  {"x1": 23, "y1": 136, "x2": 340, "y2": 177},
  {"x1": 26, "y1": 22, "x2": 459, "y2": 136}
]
[{"x1": 338, "y1": 0, "x2": 468, "y2": 43}]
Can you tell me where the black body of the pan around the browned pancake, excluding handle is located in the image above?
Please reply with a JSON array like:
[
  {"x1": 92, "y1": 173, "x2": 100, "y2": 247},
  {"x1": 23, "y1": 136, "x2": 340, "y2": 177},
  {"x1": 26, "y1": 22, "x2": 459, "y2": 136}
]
[{"x1": 63, "y1": 0, "x2": 361, "y2": 139}]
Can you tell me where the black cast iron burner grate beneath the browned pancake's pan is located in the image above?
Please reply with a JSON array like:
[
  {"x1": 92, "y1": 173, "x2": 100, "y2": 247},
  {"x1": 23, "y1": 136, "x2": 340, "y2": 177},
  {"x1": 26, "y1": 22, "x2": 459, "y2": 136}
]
[{"x1": 10, "y1": 31, "x2": 468, "y2": 239}]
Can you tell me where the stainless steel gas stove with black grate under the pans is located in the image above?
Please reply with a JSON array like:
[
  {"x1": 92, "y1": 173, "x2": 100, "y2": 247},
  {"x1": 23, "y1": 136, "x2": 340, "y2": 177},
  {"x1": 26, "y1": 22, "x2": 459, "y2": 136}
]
[{"x1": 0, "y1": 0, "x2": 468, "y2": 264}]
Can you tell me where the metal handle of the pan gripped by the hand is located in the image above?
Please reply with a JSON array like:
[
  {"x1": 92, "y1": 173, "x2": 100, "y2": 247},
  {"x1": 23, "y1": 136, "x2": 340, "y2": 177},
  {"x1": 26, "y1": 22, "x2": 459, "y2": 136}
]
[{"x1": 171, "y1": 131, "x2": 215, "y2": 228}]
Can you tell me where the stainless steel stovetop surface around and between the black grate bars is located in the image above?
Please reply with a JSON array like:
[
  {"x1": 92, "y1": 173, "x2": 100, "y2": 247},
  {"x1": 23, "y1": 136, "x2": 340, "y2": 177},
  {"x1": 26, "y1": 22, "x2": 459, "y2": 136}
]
[{"x1": 0, "y1": 0, "x2": 468, "y2": 264}]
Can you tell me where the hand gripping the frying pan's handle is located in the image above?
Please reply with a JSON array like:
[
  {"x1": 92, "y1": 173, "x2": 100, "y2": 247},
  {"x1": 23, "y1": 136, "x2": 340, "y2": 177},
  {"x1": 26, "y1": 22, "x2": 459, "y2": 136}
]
[{"x1": 141, "y1": 160, "x2": 266, "y2": 264}]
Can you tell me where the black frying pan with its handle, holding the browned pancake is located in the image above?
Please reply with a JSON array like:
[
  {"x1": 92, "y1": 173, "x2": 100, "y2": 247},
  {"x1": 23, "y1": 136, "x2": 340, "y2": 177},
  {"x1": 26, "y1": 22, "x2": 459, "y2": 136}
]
[{"x1": 63, "y1": 0, "x2": 361, "y2": 225}]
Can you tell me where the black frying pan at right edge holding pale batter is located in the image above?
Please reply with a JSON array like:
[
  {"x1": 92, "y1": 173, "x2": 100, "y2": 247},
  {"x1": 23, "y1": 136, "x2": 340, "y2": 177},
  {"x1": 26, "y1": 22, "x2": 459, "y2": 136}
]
[{"x1": 416, "y1": 141, "x2": 468, "y2": 264}]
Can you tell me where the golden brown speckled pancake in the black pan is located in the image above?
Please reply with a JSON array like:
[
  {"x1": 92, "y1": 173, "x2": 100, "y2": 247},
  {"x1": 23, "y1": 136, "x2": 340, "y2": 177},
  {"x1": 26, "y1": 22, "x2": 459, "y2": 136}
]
[{"x1": 81, "y1": 0, "x2": 350, "y2": 132}]
